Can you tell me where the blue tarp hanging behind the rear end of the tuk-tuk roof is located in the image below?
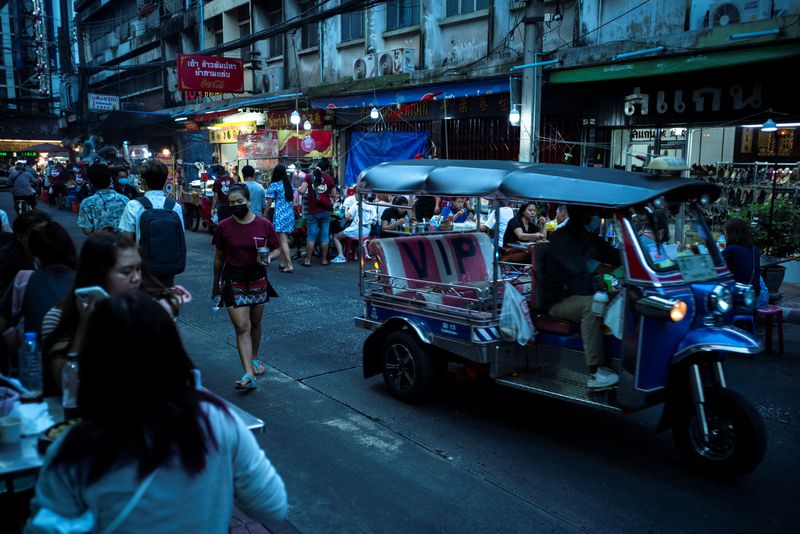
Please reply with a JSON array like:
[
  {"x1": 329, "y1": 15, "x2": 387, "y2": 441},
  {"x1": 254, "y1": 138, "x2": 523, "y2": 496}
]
[{"x1": 345, "y1": 132, "x2": 428, "y2": 186}]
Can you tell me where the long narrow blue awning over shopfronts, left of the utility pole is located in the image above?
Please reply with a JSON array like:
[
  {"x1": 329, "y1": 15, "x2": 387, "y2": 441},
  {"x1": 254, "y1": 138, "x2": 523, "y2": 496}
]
[{"x1": 311, "y1": 78, "x2": 509, "y2": 109}]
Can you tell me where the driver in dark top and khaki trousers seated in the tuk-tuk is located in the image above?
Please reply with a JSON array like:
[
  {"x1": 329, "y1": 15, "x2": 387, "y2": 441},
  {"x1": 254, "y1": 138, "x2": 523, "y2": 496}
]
[{"x1": 540, "y1": 206, "x2": 621, "y2": 388}]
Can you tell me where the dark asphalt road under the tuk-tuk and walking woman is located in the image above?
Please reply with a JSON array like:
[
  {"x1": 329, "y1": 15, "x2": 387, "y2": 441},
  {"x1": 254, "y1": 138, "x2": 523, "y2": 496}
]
[{"x1": 0, "y1": 193, "x2": 800, "y2": 533}]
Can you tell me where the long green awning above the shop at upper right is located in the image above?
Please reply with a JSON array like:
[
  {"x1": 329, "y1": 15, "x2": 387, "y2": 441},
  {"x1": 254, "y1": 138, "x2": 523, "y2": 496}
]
[{"x1": 550, "y1": 43, "x2": 800, "y2": 84}]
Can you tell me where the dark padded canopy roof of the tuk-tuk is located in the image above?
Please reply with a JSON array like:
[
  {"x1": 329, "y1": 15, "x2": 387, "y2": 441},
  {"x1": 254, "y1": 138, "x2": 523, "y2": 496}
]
[{"x1": 358, "y1": 159, "x2": 720, "y2": 208}]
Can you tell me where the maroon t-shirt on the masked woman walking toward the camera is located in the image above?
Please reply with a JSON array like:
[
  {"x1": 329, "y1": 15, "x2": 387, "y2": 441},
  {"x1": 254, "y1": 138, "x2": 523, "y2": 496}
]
[{"x1": 214, "y1": 215, "x2": 281, "y2": 267}]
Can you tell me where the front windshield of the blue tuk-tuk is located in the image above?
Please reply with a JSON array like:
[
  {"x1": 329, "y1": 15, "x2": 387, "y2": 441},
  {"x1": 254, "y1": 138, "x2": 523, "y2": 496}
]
[{"x1": 631, "y1": 203, "x2": 724, "y2": 279}]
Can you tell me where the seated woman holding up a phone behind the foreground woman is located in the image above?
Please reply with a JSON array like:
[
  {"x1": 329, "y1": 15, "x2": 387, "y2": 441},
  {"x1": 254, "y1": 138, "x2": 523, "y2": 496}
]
[{"x1": 42, "y1": 232, "x2": 192, "y2": 391}]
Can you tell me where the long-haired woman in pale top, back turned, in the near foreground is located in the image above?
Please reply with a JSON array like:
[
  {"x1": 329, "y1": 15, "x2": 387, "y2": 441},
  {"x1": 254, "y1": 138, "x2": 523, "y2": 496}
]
[{"x1": 26, "y1": 292, "x2": 287, "y2": 533}]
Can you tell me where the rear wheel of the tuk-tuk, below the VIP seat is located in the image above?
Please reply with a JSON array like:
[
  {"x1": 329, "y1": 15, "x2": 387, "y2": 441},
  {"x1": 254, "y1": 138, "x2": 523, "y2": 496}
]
[{"x1": 383, "y1": 330, "x2": 436, "y2": 403}]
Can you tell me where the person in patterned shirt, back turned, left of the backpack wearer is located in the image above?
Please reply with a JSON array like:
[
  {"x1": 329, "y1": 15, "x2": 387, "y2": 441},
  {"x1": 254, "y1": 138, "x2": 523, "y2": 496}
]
[{"x1": 78, "y1": 163, "x2": 128, "y2": 235}]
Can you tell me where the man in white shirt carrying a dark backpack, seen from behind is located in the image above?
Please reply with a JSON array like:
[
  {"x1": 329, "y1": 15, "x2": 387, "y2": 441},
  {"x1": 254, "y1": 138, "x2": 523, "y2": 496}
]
[{"x1": 119, "y1": 160, "x2": 186, "y2": 287}]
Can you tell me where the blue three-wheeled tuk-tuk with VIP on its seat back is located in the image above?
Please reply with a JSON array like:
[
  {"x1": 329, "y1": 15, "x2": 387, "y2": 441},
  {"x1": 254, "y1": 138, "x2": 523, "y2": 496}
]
[{"x1": 355, "y1": 160, "x2": 766, "y2": 478}]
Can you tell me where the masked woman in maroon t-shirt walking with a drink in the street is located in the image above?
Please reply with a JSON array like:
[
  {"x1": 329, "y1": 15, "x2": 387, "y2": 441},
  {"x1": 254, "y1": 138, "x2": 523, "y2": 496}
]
[{"x1": 211, "y1": 184, "x2": 280, "y2": 389}]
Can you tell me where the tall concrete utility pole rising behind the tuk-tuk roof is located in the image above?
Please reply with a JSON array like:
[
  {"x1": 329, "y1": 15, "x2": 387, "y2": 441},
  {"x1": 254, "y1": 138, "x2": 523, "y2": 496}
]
[{"x1": 519, "y1": 0, "x2": 544, "y2": 162}]
